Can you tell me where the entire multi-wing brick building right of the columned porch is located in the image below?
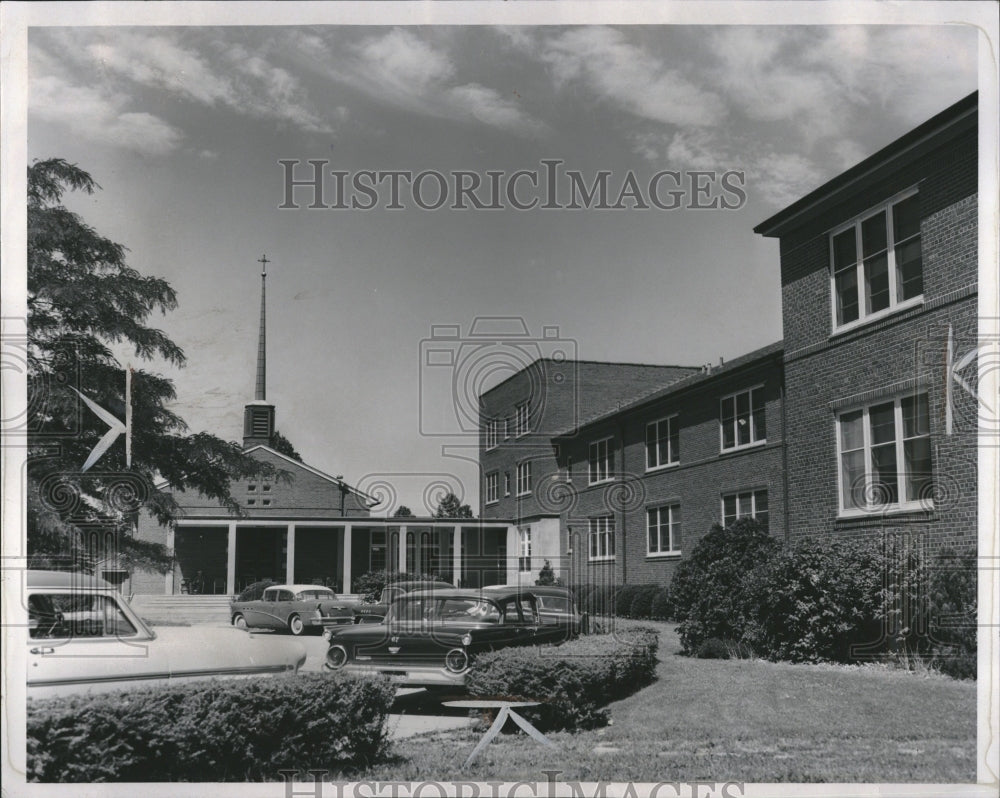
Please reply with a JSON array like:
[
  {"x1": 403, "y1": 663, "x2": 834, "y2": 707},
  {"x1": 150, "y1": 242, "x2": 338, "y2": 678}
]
[{"x1": 480, "y1": 94, "x2": 978, "y2": 583}]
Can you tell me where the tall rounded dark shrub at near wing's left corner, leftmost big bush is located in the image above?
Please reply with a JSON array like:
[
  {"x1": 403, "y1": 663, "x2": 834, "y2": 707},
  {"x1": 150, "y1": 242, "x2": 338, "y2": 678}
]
[{"x1": 670, "y1": 518, "x2": 778, "y2": 654}]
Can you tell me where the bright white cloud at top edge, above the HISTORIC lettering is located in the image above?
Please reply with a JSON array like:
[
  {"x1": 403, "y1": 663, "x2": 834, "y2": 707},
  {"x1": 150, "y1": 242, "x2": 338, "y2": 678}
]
[{"x1": 295, "y1": 28, "x2": 548, "y2": 136}]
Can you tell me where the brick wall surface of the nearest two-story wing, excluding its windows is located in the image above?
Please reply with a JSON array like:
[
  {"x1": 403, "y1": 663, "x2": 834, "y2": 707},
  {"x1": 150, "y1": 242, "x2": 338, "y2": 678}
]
[{"x1": 781, "y1": 122, "x2": 978, "y2": 545}]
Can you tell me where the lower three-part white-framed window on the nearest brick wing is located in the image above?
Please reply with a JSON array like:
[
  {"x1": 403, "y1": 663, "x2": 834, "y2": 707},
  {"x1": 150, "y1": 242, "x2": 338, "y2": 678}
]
[{"x1": 837, "y1": 394, "x2": 934, "y2": 514}]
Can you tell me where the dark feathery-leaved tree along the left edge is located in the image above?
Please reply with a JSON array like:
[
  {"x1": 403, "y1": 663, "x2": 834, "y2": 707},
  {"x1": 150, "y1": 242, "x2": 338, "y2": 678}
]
[{"x1": 27, "y1": 158, "x2": 282, "y2": 571}]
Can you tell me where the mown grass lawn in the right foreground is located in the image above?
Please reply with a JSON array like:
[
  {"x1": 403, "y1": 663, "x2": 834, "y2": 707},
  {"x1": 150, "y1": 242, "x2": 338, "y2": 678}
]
[{"x1": 361, "y1": 624, "x2": 976, "y2": 783}]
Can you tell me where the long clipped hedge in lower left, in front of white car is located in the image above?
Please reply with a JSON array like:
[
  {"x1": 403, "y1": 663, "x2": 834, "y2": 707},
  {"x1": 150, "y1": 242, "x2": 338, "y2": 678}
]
[{"x1": 27, "y1": 674, "x2": 395, "y2": 782}]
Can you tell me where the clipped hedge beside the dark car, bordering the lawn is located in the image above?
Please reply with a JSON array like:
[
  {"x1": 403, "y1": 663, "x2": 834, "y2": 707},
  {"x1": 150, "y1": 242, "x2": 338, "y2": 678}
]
[{"x1": 466, "y1": 627, "x2": 659, "y2": 730}]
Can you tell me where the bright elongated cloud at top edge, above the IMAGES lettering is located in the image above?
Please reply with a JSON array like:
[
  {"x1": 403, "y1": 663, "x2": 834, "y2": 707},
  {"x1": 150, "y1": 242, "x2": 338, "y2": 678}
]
[{"x1": 539, "y1": 27, "x2": 726, "y2": 126}]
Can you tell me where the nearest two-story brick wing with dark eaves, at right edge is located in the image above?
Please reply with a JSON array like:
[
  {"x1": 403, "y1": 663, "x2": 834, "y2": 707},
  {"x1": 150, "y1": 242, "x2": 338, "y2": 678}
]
[{"x1": 755, "y1": 94, "x2": 978, "y2": 544}]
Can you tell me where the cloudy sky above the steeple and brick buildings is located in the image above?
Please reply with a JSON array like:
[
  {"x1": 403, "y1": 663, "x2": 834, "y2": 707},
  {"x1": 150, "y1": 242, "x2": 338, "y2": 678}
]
[{"x1": 28, "y1": 20, "x2": 977, "y2": 514}]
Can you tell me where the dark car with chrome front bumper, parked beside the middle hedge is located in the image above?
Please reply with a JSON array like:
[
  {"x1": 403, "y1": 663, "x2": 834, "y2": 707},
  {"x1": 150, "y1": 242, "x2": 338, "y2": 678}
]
[{"x1": 324, "y1": 588, "x2": 571, "y2": 688}]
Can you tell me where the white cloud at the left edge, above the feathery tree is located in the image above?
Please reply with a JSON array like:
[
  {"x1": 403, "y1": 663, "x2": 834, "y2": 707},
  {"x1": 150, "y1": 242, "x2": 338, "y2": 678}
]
[{"x1": 29, "y1": 75, "x2": 184, "y2": 155}]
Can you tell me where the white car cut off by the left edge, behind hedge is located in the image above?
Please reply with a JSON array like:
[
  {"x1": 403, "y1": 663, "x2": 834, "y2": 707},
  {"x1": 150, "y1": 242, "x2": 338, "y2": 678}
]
[{"x1": 25, "y1": 571, "x2": 306, "y2": 698}]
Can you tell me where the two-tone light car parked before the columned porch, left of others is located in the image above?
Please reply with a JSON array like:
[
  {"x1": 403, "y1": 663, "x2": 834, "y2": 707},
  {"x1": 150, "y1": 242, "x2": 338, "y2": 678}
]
[{"x1": 229, "y1": 585, "x2": 354, "y2": 635}]
